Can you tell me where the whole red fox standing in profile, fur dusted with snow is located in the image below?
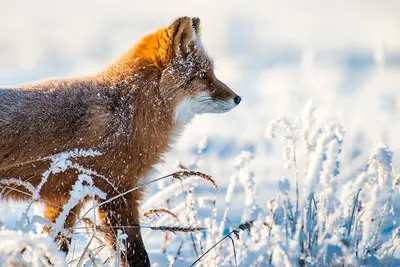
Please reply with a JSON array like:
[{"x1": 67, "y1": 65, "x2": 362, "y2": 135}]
[{"x1": 0, "y1": 17, "x2": 241, "y2": 266}]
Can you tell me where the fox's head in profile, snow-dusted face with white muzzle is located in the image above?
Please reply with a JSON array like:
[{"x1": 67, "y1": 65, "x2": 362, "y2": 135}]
[{"x1": 125, "y1": 17, "x2": 241, "y2": 123}]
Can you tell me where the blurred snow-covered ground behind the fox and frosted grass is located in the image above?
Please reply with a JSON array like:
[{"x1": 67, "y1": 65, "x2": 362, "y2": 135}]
[{"x1": 0, "y1": 0, "x2": 400, "y2": 266}]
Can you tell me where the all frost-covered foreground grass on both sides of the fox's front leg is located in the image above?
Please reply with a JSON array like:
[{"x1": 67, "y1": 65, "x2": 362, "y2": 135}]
[{"x1": 0, "y1": 102, "x2": 400, "y2": 266}]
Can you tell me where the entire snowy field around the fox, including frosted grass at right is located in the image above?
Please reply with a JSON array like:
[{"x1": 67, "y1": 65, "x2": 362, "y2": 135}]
[{"x1": 0, "y1": 0, "x2": 400, "y2": 266}]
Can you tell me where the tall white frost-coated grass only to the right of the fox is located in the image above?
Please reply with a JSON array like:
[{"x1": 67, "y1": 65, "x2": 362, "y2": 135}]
[{"x1": 144, "y1": 103, "x2": 400, "y2": 266}]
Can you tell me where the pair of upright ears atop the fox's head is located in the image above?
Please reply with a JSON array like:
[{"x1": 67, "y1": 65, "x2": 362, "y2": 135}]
[{"x1": 171, "y1": 17, "x2": 200, "y2": 57}]
